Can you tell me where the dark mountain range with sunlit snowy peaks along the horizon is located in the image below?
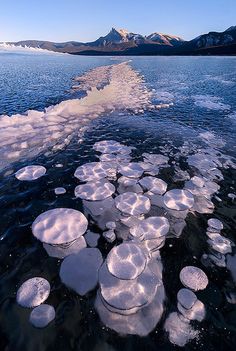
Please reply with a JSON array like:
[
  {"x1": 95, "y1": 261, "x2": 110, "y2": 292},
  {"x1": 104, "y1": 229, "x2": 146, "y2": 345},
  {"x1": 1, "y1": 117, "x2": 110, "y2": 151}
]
[{"x1": 4, "y1": 26, "x2": 236, "y2": 55}]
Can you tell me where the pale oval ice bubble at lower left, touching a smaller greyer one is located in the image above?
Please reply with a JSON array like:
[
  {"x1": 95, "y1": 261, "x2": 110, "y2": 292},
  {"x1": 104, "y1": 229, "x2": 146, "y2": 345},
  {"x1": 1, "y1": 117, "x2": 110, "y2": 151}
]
[{"x1": 16, "y1": 277, "x2": 50, "y2": 308}]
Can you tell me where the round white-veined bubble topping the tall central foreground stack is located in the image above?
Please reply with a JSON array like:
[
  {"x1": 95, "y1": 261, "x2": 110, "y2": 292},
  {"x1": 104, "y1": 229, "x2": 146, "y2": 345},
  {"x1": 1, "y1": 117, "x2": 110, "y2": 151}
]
[{"x1": 107, "y1": 243, "x2": 147, "y2": 279}]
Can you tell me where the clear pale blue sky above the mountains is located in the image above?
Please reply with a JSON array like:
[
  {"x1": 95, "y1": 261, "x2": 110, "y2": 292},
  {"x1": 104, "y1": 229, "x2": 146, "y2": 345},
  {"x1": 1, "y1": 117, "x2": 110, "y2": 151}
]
[{"x1": 0, "y1": 0, "x2": 236, "y2": 42}]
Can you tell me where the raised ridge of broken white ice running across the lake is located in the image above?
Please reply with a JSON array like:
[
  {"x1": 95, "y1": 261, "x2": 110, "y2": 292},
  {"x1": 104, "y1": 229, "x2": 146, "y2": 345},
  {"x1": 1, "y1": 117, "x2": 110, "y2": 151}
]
[{"x1": 0, "y1": 62, "x2": 155, "y2": 168}]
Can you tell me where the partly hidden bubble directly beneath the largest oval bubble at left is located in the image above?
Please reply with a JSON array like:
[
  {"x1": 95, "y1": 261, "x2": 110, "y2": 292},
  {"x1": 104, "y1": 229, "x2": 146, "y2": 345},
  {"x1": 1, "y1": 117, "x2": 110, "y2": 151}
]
[{"x1": 43, "y1": 236, "x2": 87, "y2": 259}]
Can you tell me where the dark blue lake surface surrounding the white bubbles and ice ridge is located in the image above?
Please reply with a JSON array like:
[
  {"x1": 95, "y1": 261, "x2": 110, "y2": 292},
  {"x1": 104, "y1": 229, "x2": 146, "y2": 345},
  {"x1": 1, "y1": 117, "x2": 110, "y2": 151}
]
[{"x1": 0, "y1": 54, "x2": 236, "y2": 351}]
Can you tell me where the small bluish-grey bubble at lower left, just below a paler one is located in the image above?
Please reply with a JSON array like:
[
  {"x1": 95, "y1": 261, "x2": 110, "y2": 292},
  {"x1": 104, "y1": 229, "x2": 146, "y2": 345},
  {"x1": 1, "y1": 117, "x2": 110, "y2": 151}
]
[{"x1": 30, "y1": 304, "x2": 56, "y2": 328}]
